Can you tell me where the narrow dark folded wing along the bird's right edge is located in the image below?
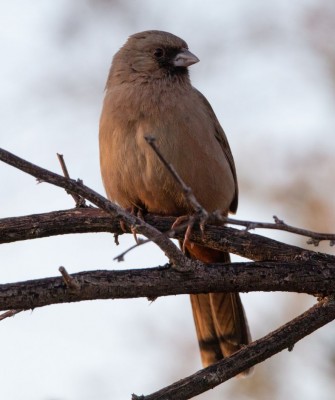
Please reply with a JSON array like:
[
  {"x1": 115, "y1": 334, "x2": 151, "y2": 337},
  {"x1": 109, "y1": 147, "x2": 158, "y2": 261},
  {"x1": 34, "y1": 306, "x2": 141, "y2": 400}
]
[{"x1": 194, "y1": 88, "x2": 238, "y2": 213}]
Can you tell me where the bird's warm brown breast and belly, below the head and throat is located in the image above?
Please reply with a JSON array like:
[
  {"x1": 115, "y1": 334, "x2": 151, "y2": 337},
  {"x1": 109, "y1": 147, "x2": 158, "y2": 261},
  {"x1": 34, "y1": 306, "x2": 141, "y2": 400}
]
[{"x1": 100, "y1": 84, "x2": 235, "y2": 215}]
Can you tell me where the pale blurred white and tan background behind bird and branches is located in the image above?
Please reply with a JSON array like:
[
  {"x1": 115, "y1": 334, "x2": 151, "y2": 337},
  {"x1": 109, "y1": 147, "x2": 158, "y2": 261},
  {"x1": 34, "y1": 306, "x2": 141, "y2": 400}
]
[{"x1": 0, "y1": 0, "x2": 335, "y2": 400}]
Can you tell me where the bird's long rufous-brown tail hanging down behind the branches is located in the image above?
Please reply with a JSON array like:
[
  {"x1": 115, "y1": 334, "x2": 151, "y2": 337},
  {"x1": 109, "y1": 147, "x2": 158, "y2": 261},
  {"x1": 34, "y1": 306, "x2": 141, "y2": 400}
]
[{"x1": 186, "y1": 243, "x2": 251, "y2": 375}]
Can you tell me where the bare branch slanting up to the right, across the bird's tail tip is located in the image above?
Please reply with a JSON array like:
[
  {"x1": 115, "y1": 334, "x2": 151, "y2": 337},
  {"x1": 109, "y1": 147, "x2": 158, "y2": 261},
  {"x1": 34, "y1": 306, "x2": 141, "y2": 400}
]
[{"x1": 132, "y1": 298, "x2": 335, "y2": 400}]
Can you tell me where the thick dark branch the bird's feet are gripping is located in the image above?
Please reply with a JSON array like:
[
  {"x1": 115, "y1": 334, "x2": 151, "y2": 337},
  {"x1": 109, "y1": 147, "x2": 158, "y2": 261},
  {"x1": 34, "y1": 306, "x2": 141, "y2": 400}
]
[{"x1": 0, "y1": 207, "x2": 335, "y2": 263}]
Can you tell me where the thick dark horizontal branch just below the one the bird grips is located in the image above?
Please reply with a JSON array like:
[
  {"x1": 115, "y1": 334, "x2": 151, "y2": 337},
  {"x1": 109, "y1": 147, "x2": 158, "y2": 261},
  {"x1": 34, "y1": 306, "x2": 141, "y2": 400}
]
[{"x1": 0, "y1": 261, "x2": 335, "y2": 310}]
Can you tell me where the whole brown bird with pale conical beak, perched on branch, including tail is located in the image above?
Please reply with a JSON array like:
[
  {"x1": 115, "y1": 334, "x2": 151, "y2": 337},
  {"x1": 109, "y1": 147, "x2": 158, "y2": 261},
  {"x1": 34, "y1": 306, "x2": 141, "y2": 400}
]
[{"x1": 99, "y1": 31, "x2": 250, "y2": 372}]
